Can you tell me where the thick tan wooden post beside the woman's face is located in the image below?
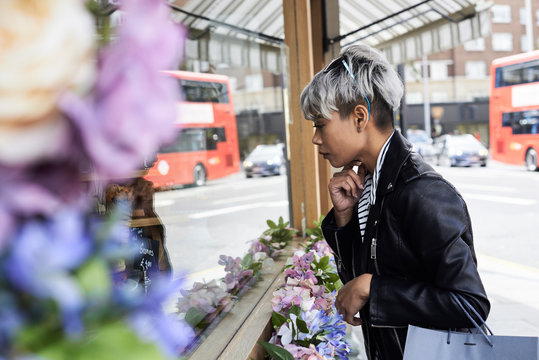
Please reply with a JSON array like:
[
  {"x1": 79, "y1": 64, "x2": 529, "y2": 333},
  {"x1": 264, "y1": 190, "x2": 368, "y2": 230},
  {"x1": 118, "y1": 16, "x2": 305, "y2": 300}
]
[{"x1": 283, "y1": 0, "x2": 340, "y2": 229}]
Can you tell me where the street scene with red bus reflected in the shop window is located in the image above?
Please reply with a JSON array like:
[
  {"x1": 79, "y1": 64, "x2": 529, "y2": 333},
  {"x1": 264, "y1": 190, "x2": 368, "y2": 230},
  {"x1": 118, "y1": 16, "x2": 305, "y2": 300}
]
[{"x1": 150, "y1": 7, "x2": 289, "y2": 282}]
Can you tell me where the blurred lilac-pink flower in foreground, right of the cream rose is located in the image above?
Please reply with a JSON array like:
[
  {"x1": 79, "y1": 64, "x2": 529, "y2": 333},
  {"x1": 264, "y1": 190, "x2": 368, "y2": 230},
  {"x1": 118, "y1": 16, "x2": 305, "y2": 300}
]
[{"x1": 61, "y1": 0, "x2": 185, "y2": 178}]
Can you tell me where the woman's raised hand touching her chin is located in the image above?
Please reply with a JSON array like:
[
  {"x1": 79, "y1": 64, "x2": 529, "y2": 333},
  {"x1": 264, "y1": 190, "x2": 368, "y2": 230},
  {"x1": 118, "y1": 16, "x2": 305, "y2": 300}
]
[{"x1": 328, "y1": 160, "x2": 365, "y2": 226}]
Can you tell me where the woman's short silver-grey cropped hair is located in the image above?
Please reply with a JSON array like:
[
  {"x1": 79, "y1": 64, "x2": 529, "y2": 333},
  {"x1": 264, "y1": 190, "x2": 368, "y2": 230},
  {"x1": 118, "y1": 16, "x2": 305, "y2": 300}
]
[{"x1": 300, "y1": 45, "x2": 404, "y2": 130}]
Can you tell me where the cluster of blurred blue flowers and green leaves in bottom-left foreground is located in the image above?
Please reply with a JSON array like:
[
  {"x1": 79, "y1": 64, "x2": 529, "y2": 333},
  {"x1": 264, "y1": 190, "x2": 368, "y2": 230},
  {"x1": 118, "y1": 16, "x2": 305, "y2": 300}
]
[{"x1": 0, "y1": 209, "x2": 194, "y2": 359}]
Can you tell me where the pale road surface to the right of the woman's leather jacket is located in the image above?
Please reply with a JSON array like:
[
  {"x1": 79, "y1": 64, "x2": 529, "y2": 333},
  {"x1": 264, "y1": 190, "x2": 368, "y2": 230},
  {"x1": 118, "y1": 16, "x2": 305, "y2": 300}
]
[{"x1": 437, "y1": 161, "x2": 539, "y2": 336}]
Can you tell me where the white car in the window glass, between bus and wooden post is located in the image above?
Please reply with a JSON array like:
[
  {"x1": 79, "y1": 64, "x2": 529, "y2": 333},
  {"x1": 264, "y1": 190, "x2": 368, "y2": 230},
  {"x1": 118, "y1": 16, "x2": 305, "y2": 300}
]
[{"x1": 243, "y1": 144, "x2": 286, "y2": 178}]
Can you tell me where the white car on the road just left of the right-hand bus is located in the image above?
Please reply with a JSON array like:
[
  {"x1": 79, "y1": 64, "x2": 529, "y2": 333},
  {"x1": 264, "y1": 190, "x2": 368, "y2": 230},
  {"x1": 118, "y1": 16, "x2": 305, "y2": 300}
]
[{"x1": 434, "y1": 134, "x2": 488, "y2": 166}]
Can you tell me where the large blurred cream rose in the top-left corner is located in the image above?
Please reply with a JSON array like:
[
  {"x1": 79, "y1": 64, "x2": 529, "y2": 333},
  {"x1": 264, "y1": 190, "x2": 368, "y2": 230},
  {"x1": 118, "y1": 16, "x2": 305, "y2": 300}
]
[{"x1": 0, "y1": 0, "x2": 96, "y2": 165}]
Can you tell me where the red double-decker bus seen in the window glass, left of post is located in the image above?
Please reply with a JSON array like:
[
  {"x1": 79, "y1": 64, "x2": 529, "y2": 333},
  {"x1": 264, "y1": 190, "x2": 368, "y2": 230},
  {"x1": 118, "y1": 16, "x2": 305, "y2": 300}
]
[{"x1": 145, "y1": 71, "x2": 240, "y2": 188}]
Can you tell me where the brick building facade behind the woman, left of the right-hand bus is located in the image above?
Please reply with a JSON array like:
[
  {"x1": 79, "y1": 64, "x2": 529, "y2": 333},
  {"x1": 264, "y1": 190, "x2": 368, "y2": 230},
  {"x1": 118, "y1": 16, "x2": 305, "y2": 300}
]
[{"x1": 405, "y1": 0, "x2": 539, "y2": 145}]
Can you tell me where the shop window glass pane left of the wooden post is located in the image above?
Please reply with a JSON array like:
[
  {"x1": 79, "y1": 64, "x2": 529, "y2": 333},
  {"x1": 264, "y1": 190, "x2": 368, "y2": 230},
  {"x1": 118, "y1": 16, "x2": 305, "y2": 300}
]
[{"x1": 87, "y1": 1, "x2": 290, "y2": 354}]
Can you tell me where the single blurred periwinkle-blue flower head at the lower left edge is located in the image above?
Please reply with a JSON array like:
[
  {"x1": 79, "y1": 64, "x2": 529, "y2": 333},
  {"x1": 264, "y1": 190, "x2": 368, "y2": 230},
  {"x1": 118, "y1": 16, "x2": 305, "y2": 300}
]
[{"x1": 2, "y1": 209, "x2": 92, "y2": 334}]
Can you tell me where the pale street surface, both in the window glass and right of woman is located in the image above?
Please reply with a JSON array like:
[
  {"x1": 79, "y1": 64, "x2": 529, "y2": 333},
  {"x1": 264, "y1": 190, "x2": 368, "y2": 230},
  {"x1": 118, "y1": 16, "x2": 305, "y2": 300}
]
[{"x1": 155, "y1": 161, "x2": 539, "y2": 336}]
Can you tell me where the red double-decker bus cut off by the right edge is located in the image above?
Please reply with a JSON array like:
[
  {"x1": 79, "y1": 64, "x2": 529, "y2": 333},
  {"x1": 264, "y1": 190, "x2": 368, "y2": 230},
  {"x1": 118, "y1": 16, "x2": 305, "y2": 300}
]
[{"x1": 490, "y1": 51, "x2": 539, "y2": 171}]
